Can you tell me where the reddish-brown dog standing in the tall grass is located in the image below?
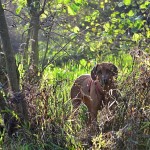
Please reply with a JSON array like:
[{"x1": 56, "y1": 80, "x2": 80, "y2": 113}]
[{"x1": 71, "y1": 63, "x2": 118, "y2": 124}]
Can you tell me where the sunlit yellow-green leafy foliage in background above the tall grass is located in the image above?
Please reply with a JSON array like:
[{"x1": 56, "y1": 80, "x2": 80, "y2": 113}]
[{"x1": 4, "y1": 0, "x2": 150, "y2": 69}]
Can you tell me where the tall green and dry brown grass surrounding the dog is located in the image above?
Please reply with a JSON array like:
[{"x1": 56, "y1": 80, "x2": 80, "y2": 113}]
[{"x1": 1, "y1": 52, "x2": 150, "y2": 150}]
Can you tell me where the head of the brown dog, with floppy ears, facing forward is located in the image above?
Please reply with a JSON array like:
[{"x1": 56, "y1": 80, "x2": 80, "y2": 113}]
[{"x1": 91, "y1": 63, "x2": 118, "y2": 86}]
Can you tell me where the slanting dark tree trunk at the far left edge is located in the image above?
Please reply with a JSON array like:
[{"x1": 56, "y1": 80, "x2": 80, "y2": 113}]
[{"x1": 0, "y1": 0, "x2": 28, "y2": 135}]
